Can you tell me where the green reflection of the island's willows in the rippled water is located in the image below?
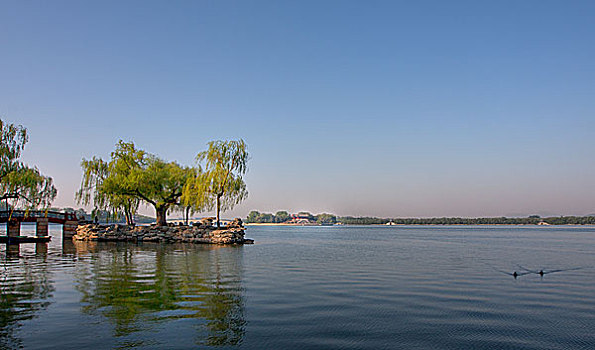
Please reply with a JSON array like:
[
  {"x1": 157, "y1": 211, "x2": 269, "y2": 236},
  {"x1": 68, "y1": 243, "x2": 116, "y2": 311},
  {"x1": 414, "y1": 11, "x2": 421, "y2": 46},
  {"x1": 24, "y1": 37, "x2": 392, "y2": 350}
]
[{"x1": 75, "y1": 242, "x2": 246, "y2": 347}]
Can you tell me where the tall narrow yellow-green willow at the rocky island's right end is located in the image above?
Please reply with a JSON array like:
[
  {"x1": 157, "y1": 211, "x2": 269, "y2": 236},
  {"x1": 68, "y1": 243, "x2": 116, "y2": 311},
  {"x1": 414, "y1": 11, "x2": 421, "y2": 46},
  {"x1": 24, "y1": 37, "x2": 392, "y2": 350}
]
[{"x1": 191, "y1": 139, "x2": 249, "y2": 227}]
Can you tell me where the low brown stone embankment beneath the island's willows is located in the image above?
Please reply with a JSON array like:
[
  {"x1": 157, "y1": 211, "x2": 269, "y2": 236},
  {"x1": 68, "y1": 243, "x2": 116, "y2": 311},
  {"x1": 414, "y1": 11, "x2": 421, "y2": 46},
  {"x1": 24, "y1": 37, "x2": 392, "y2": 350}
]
[{"x1": 72, "y1": 218, "x2": 254, "y2": 244}]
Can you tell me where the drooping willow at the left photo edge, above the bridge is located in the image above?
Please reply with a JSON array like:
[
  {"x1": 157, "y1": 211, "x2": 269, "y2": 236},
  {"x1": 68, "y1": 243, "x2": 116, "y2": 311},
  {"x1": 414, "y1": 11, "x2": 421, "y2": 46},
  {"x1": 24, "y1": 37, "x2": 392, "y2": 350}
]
[{"x1": 0, "y1": 119, "x2": 57, "y2": 208}]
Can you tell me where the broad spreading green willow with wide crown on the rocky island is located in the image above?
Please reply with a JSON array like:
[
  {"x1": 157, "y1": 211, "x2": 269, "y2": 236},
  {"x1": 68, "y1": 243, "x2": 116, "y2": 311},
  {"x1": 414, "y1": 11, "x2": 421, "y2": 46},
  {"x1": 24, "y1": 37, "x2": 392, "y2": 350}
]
[{"x1": 77, "y1": 140, "x2": 192, "y2": 226}]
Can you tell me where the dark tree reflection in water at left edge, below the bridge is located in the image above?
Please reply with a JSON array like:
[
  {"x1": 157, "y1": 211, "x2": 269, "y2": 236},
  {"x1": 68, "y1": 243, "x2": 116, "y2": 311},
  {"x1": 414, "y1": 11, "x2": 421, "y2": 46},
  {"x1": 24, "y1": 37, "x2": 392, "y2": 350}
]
[{"x1": 0, "y1": 245, "x2": 54, "y2": 349}]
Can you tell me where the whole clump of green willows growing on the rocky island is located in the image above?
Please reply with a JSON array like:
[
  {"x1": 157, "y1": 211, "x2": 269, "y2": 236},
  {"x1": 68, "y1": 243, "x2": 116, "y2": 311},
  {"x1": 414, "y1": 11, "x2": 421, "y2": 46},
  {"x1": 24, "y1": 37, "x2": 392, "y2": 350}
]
[{"x1": 76, "y1": 140, "x2": 248, "y2": 226}]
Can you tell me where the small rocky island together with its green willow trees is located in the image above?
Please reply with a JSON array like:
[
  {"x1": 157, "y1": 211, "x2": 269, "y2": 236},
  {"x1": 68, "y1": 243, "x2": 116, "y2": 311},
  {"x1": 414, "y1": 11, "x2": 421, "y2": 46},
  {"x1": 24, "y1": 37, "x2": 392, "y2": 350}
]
[{"x1": 72, "y1": 140, "x2": 253, "y2": 244}]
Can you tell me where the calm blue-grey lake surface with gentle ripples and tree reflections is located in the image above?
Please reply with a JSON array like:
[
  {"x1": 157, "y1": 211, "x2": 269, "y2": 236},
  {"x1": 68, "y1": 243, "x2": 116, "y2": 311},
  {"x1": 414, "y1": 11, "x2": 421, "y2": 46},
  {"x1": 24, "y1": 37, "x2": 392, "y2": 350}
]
[{"x1": 0, "y1": 225, "x2": 595, "y2": 349}]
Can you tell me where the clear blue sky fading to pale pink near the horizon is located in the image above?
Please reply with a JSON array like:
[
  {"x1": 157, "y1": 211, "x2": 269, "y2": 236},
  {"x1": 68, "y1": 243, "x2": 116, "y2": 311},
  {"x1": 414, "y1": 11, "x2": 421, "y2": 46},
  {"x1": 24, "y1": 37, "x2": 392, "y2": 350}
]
[{"x1": 0, "y1": 0, "x2": 595, "y2": 217}]
